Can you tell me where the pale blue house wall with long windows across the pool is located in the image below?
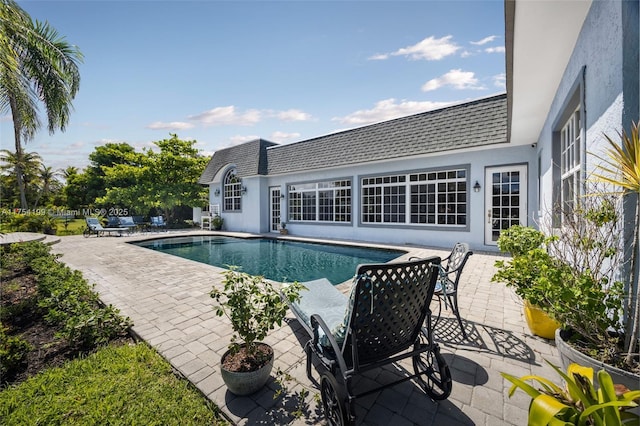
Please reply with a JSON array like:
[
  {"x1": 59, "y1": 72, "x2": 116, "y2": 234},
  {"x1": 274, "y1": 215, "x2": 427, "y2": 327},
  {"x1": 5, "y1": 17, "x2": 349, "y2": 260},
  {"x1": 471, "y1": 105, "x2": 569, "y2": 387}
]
[{"x1": 250, "y1": 146, "x2": 537, "y2": 250}]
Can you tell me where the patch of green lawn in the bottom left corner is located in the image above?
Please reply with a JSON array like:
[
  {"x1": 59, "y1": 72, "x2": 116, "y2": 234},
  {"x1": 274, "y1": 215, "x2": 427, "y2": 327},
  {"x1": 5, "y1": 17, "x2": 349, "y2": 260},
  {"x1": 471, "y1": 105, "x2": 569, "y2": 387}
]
[{"x1": 0, "y1": 343, "x2": 227, "y2": 425}]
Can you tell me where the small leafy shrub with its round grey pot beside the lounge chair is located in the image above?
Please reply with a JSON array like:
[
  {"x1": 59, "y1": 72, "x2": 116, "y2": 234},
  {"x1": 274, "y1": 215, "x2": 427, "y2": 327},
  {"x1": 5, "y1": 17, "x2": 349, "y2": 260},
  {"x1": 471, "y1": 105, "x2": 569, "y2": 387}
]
[{"x1": 210, "y1": 266, "x2": 304, "y2": 395}]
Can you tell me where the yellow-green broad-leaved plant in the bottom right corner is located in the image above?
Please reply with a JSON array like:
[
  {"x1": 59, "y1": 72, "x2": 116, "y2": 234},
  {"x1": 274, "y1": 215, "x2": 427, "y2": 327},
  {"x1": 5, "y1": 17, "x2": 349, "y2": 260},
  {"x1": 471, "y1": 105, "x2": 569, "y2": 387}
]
[{"x1": 501, "y1": 362, "x2": 640, "y2": 426}]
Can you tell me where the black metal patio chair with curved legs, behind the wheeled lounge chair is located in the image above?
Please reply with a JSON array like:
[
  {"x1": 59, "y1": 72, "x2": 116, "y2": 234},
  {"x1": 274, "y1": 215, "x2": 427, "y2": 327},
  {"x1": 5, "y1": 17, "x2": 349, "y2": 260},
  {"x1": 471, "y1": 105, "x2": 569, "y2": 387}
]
[{"x1": 433, "y1": 243, "x2": 473, "y2": 339}]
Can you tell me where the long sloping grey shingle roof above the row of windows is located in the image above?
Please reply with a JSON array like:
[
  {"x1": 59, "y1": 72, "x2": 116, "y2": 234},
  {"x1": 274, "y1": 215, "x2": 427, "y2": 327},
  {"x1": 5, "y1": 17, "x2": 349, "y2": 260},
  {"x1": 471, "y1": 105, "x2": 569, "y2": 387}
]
[{"x1": 267, "y1": 94, "x2": 507, "y2": 174}]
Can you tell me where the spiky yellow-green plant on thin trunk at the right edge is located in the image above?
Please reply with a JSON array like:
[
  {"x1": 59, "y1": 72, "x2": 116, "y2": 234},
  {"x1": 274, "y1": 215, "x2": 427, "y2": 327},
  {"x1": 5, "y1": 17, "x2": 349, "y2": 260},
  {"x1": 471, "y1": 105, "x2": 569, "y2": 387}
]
[{"x1": 595, "y1": 123, "x2": 640, "y2": 364}]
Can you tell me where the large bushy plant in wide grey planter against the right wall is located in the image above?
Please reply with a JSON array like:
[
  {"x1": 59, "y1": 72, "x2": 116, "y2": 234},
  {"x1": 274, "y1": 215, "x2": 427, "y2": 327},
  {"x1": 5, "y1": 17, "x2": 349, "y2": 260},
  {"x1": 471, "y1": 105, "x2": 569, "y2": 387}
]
[{"x1": 494, "y1": 191, "x2": 640, "y2": 387}]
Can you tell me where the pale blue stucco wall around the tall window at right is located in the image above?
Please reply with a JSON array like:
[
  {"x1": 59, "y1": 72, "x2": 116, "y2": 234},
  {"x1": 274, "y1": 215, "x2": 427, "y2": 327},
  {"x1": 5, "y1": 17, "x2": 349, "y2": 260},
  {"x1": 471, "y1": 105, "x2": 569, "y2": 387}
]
[{"x1": 538, "y1": 1, "x2": 624, "y2": 223}]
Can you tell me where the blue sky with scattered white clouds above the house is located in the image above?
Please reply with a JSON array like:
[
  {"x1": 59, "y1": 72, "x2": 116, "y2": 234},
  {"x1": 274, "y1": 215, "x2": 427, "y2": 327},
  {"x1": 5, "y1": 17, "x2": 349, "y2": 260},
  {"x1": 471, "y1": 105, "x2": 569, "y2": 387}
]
[{"x1": 0, "y1": 0, "x2": 506, "y2": 169}]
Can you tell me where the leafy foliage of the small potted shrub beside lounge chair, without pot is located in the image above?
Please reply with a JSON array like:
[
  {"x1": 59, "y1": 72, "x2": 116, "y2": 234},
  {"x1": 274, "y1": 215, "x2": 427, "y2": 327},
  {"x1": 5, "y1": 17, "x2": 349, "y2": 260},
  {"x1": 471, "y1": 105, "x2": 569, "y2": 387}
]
[{"x1": 210, "y1": 266, "x2": 304, "y2": 372}]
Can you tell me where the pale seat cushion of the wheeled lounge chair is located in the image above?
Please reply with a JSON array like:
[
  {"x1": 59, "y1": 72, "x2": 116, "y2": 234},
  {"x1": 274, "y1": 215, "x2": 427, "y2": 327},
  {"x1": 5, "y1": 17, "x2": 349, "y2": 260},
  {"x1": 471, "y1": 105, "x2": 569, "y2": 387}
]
[{"x1": 290, "y1": 278, "x2": 350, "y2": 346}]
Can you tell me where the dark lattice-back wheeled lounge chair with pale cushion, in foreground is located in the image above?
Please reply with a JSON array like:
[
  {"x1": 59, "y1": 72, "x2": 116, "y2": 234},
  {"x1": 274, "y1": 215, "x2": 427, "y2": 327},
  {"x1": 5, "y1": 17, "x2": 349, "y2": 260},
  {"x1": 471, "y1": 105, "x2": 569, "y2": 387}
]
[{"x1": 291, "y1": 257, "x2": 452, "y2": 425}]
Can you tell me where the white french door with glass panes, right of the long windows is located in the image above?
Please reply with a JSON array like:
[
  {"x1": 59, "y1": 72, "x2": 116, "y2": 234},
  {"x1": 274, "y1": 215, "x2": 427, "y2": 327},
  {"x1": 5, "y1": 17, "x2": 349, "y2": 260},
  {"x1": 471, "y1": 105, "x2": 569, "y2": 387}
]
[{"x1": 484, "y1": 165, "x2": 527, "y2": 246}]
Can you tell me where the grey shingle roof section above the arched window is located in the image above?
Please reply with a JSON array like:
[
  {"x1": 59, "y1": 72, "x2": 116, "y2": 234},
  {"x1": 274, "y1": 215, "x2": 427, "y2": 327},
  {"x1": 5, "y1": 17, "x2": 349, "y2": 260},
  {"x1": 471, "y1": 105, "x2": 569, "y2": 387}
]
[{"x1": 198, "y1": 139, "x2": 276, "y2": 184}]
